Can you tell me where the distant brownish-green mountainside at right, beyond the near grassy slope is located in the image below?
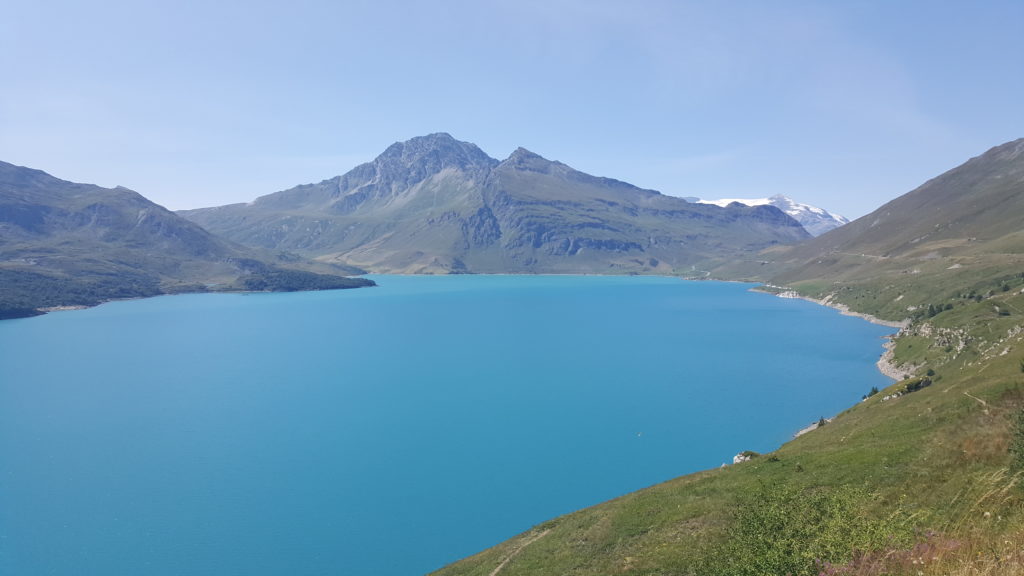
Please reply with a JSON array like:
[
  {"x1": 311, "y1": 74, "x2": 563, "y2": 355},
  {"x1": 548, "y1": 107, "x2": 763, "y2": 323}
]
[{"x1": 762, "y1": 138, "x2": 1024, "y2": 319}]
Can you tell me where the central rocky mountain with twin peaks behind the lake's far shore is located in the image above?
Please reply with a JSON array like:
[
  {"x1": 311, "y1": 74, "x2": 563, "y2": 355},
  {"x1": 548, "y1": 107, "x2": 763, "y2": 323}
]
[{"x1": 180, "y1": 133, "x2": 807, "y2": 274}]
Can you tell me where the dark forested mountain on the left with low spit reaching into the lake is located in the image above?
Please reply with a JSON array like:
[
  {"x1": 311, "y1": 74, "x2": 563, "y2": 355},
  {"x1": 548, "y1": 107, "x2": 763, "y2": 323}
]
[{"x1": 0, "y1": 162, "x2": 372, "y2": 318}]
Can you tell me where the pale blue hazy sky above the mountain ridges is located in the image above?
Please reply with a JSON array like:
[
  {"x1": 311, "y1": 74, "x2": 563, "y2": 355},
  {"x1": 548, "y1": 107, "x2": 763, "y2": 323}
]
[{"x1": 0, "y1": 0, "x2": 1024, "y2": 218}]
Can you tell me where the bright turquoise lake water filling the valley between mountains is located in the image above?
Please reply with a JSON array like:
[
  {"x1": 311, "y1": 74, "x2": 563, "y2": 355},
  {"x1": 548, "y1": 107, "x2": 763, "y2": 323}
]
[{"x1": 0, "y1": 276, "x2": 892, "y2": 576}]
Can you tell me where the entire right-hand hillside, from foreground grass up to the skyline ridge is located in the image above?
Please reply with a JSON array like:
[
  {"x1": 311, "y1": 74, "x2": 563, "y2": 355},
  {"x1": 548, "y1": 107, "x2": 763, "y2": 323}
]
[{"x1": 438, "y1": 140, "x2": 1024, "y2": 576}]
